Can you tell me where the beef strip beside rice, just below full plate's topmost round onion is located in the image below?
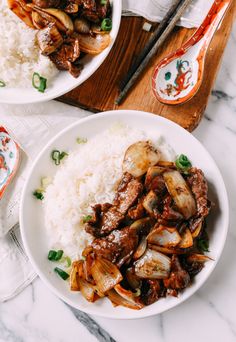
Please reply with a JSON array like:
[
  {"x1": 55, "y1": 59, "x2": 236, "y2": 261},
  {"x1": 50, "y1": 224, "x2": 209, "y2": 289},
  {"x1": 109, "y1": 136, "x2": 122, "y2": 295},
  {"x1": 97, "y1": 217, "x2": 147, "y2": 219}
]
[{"x1": 114, "y1": 172, "x2": 143, "y2": 214}]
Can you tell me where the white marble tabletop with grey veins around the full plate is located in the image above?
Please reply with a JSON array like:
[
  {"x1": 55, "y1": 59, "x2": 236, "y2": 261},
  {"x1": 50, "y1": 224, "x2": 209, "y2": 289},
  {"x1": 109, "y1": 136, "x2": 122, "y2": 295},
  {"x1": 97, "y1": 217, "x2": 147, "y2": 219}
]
[{"x1": 0, "y1": 26, "x2": 236, "y2": 342}]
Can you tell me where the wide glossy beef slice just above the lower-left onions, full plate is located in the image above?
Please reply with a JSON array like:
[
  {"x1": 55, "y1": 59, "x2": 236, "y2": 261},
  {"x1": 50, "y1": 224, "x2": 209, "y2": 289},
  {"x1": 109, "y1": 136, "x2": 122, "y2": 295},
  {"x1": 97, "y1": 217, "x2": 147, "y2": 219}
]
[{"x1": 92, "y1": 227, "x2": 138, "y2": 267}]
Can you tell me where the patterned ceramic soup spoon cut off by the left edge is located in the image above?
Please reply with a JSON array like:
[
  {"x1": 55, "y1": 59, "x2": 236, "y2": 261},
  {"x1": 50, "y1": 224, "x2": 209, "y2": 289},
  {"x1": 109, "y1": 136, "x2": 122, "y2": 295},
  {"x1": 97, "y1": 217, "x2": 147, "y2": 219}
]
[{"x1": 0, "y1": 126, "x2": 20, "y2": 199}]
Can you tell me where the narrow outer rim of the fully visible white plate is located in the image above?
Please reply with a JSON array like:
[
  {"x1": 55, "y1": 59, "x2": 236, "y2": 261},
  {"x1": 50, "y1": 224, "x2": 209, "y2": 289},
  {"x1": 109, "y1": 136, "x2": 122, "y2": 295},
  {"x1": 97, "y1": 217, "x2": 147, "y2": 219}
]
[{"x1": 19, "y1": 110, "x2": 229, "y2": 320}]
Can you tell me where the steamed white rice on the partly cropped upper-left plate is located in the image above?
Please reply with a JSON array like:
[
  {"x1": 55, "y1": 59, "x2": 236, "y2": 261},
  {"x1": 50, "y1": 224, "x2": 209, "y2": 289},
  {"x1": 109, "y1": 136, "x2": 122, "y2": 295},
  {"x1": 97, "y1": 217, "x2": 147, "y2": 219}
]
[{"x1": 0, "y1": 0, "x2": 58, "y2": 88}]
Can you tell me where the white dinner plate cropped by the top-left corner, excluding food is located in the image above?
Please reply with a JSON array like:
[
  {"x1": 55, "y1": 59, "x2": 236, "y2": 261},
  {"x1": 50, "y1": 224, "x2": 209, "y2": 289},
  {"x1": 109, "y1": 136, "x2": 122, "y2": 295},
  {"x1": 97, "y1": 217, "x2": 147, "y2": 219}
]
[{"x1": 0, "y1": 0, "x2": 122, "y2": 104}]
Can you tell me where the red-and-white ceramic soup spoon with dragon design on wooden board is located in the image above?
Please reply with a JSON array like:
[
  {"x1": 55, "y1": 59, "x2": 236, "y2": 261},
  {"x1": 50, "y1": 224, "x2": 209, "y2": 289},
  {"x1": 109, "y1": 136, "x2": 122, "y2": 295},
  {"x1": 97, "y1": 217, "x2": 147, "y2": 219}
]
[{"x1": 152, "y1": 0, "x2": 231, "y2": 105}]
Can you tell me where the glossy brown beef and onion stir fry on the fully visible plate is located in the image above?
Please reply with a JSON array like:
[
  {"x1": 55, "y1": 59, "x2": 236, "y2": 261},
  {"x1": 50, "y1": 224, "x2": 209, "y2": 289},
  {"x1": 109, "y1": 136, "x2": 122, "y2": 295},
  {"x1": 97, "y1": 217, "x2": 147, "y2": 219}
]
[{"x1": 70, "y1": 141, "x2": 210, "y2": 310}]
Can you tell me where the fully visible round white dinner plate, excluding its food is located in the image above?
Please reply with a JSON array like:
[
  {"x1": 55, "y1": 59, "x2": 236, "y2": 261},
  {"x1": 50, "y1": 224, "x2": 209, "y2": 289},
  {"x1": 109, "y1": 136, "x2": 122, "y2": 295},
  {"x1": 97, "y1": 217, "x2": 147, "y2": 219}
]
[{"x1": 20, "y1": 110, "x2": 229, "y2": 319}]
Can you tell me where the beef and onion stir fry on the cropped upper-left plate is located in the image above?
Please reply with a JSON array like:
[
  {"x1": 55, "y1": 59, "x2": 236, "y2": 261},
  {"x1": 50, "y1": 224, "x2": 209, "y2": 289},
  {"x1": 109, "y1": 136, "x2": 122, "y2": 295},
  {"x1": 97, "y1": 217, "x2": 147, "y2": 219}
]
[{"x1": 8, "y1": 0, "x2": 112, "y2": 77}]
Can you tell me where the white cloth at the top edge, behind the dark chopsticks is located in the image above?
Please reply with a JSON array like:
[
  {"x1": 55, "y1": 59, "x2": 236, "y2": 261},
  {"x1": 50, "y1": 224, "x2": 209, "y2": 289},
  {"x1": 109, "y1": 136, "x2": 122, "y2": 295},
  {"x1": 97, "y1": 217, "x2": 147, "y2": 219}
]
[{"x1": 123, "y1": 0, "x2": 214, "y2": 28}]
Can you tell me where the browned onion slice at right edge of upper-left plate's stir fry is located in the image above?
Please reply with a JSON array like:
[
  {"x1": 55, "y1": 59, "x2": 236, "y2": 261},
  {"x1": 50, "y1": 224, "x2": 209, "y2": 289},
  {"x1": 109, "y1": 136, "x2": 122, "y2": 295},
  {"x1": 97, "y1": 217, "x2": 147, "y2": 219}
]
[{"x1": 79, "y1": 34, "x2": 111, "y2": 55}]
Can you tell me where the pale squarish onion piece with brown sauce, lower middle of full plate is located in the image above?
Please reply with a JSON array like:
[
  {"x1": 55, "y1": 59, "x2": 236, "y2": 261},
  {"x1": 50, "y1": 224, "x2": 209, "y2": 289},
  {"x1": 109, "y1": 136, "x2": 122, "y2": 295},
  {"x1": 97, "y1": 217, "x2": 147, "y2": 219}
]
[{"x1": 134, "y1": 249, "x2": 171, "y2": 279}]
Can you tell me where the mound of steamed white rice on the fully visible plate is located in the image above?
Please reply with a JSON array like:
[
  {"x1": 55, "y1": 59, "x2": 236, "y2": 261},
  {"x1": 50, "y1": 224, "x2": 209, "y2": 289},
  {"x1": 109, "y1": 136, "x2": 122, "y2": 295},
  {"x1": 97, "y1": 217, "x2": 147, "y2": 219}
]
[{"x1": 43, "y1": 124, "x2": 175, "y2": 258}]
